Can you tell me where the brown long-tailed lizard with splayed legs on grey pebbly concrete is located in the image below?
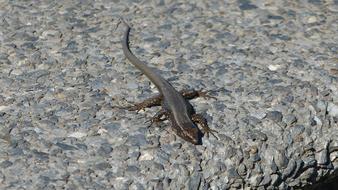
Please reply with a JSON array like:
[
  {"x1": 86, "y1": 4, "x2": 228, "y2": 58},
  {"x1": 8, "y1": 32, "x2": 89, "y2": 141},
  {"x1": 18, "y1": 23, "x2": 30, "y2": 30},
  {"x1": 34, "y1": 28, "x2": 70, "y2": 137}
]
[{"x1": 122, "y1": 19, "x2": 216, "y2": 145}]
